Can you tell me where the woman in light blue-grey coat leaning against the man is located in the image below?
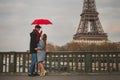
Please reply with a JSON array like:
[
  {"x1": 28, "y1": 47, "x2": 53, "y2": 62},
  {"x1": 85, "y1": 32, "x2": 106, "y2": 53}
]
[{"x1": 37, "y1": 34, "x2": 47, "y2": 76}]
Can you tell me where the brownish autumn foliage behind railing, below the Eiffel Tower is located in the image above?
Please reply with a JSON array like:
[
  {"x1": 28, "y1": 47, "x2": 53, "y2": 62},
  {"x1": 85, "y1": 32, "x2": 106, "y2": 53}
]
[{"x1": 47, "y1": 42, "x2": 120, "y2": 51}]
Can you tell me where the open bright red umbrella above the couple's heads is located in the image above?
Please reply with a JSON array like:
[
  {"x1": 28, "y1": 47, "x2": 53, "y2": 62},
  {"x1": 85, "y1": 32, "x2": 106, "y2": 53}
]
[{"x1": 32, "y1": 19, "x2": 52, "y2": 25}]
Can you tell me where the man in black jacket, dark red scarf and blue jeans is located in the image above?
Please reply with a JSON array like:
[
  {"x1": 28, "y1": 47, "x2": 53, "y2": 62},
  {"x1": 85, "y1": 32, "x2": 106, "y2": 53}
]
[{"x1": 28, "y1": 25, "x2": 42, "y2": 76}]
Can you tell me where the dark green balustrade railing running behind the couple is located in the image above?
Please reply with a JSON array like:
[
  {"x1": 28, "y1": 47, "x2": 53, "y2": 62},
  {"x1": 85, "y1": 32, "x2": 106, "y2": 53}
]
[{"x1": 0, "y1": 51, "x2": 120, "y2": 73}]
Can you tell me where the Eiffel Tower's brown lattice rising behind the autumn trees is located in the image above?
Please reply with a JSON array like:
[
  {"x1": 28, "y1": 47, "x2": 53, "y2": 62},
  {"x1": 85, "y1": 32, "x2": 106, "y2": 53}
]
[{"x1": 73, "y1": 0, "x2": 108, "y2": 41}]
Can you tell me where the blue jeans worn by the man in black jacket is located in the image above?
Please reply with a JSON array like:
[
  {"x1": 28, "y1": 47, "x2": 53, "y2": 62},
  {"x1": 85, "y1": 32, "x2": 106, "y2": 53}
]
[{"x1": 29, "y1": 53, "x2": 37, "y2": 74}]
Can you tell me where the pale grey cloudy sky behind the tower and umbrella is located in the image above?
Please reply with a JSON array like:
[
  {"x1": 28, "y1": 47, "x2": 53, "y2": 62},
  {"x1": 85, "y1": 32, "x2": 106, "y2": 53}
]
[{"x1": 0, "y1": 0, "x2": 120, "y2": 52}]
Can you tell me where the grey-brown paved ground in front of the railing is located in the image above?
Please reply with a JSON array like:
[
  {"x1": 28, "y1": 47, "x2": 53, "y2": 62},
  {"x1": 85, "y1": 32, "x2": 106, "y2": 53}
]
[{"x1": 0, "y1": 75, "x2": 120, "y2": 80}]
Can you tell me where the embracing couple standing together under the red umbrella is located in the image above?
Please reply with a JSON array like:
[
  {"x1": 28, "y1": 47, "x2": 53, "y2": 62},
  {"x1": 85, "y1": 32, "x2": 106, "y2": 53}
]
[{"x1": 28, "y1": 25, "x2": 47, "y2": 76}]
